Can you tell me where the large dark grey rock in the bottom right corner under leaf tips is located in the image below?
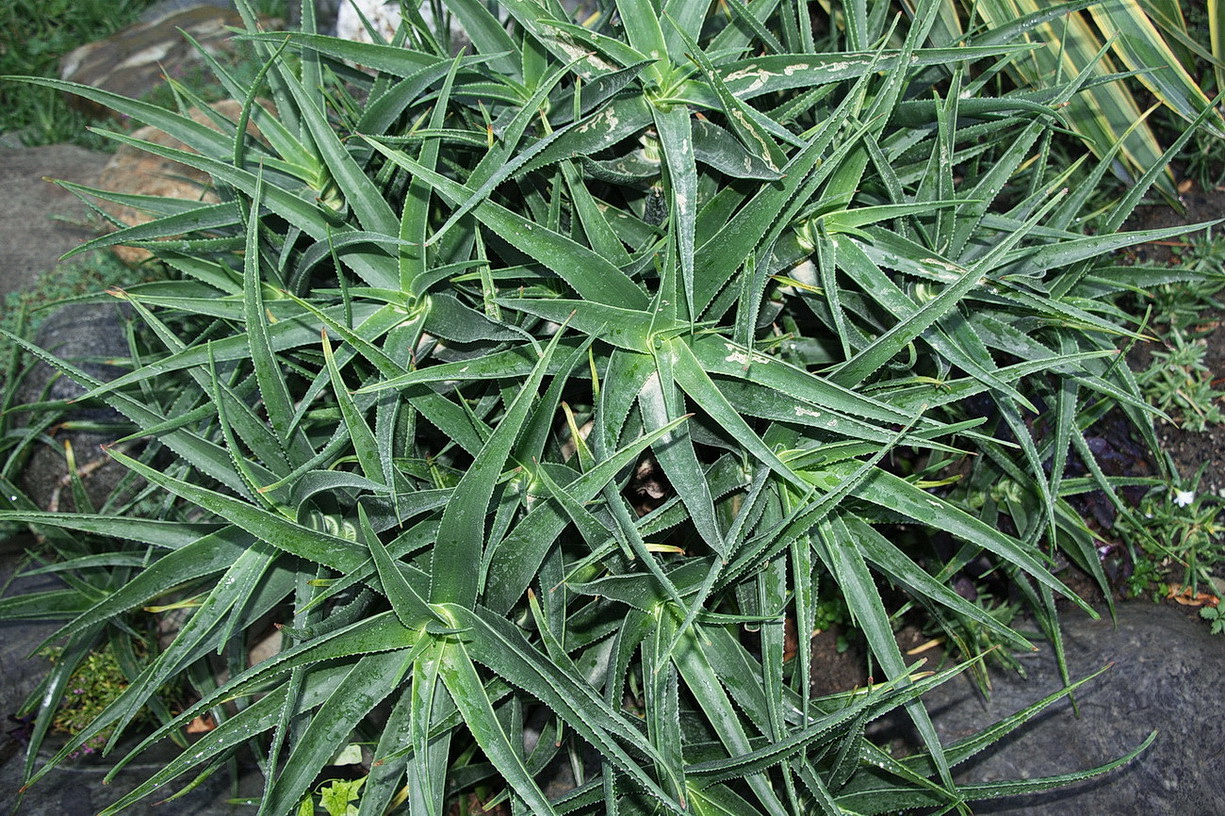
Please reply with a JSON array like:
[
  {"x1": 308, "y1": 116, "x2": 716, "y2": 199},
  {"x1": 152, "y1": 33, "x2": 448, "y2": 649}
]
[{"x1": 924, "y1": 602, "x2": 1225, "y2": 816}]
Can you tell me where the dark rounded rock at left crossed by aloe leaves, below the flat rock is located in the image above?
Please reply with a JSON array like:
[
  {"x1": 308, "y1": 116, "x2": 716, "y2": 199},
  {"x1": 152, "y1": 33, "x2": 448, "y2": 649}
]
[{"x1": 18, "y1": 303, "x2": 129, "y2": 510}]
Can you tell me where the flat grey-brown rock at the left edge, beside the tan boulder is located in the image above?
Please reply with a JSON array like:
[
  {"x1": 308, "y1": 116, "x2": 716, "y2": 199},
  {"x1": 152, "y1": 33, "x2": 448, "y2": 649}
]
[{"x1": 0, "y1": 145, "x2": 109, "y2": 297}]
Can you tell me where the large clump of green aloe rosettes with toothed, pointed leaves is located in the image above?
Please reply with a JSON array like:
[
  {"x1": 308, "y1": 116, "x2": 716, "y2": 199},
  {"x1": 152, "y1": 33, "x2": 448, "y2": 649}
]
[{"x1": 0, "y1": 0, "x2": 1195, "y2": 816}]
